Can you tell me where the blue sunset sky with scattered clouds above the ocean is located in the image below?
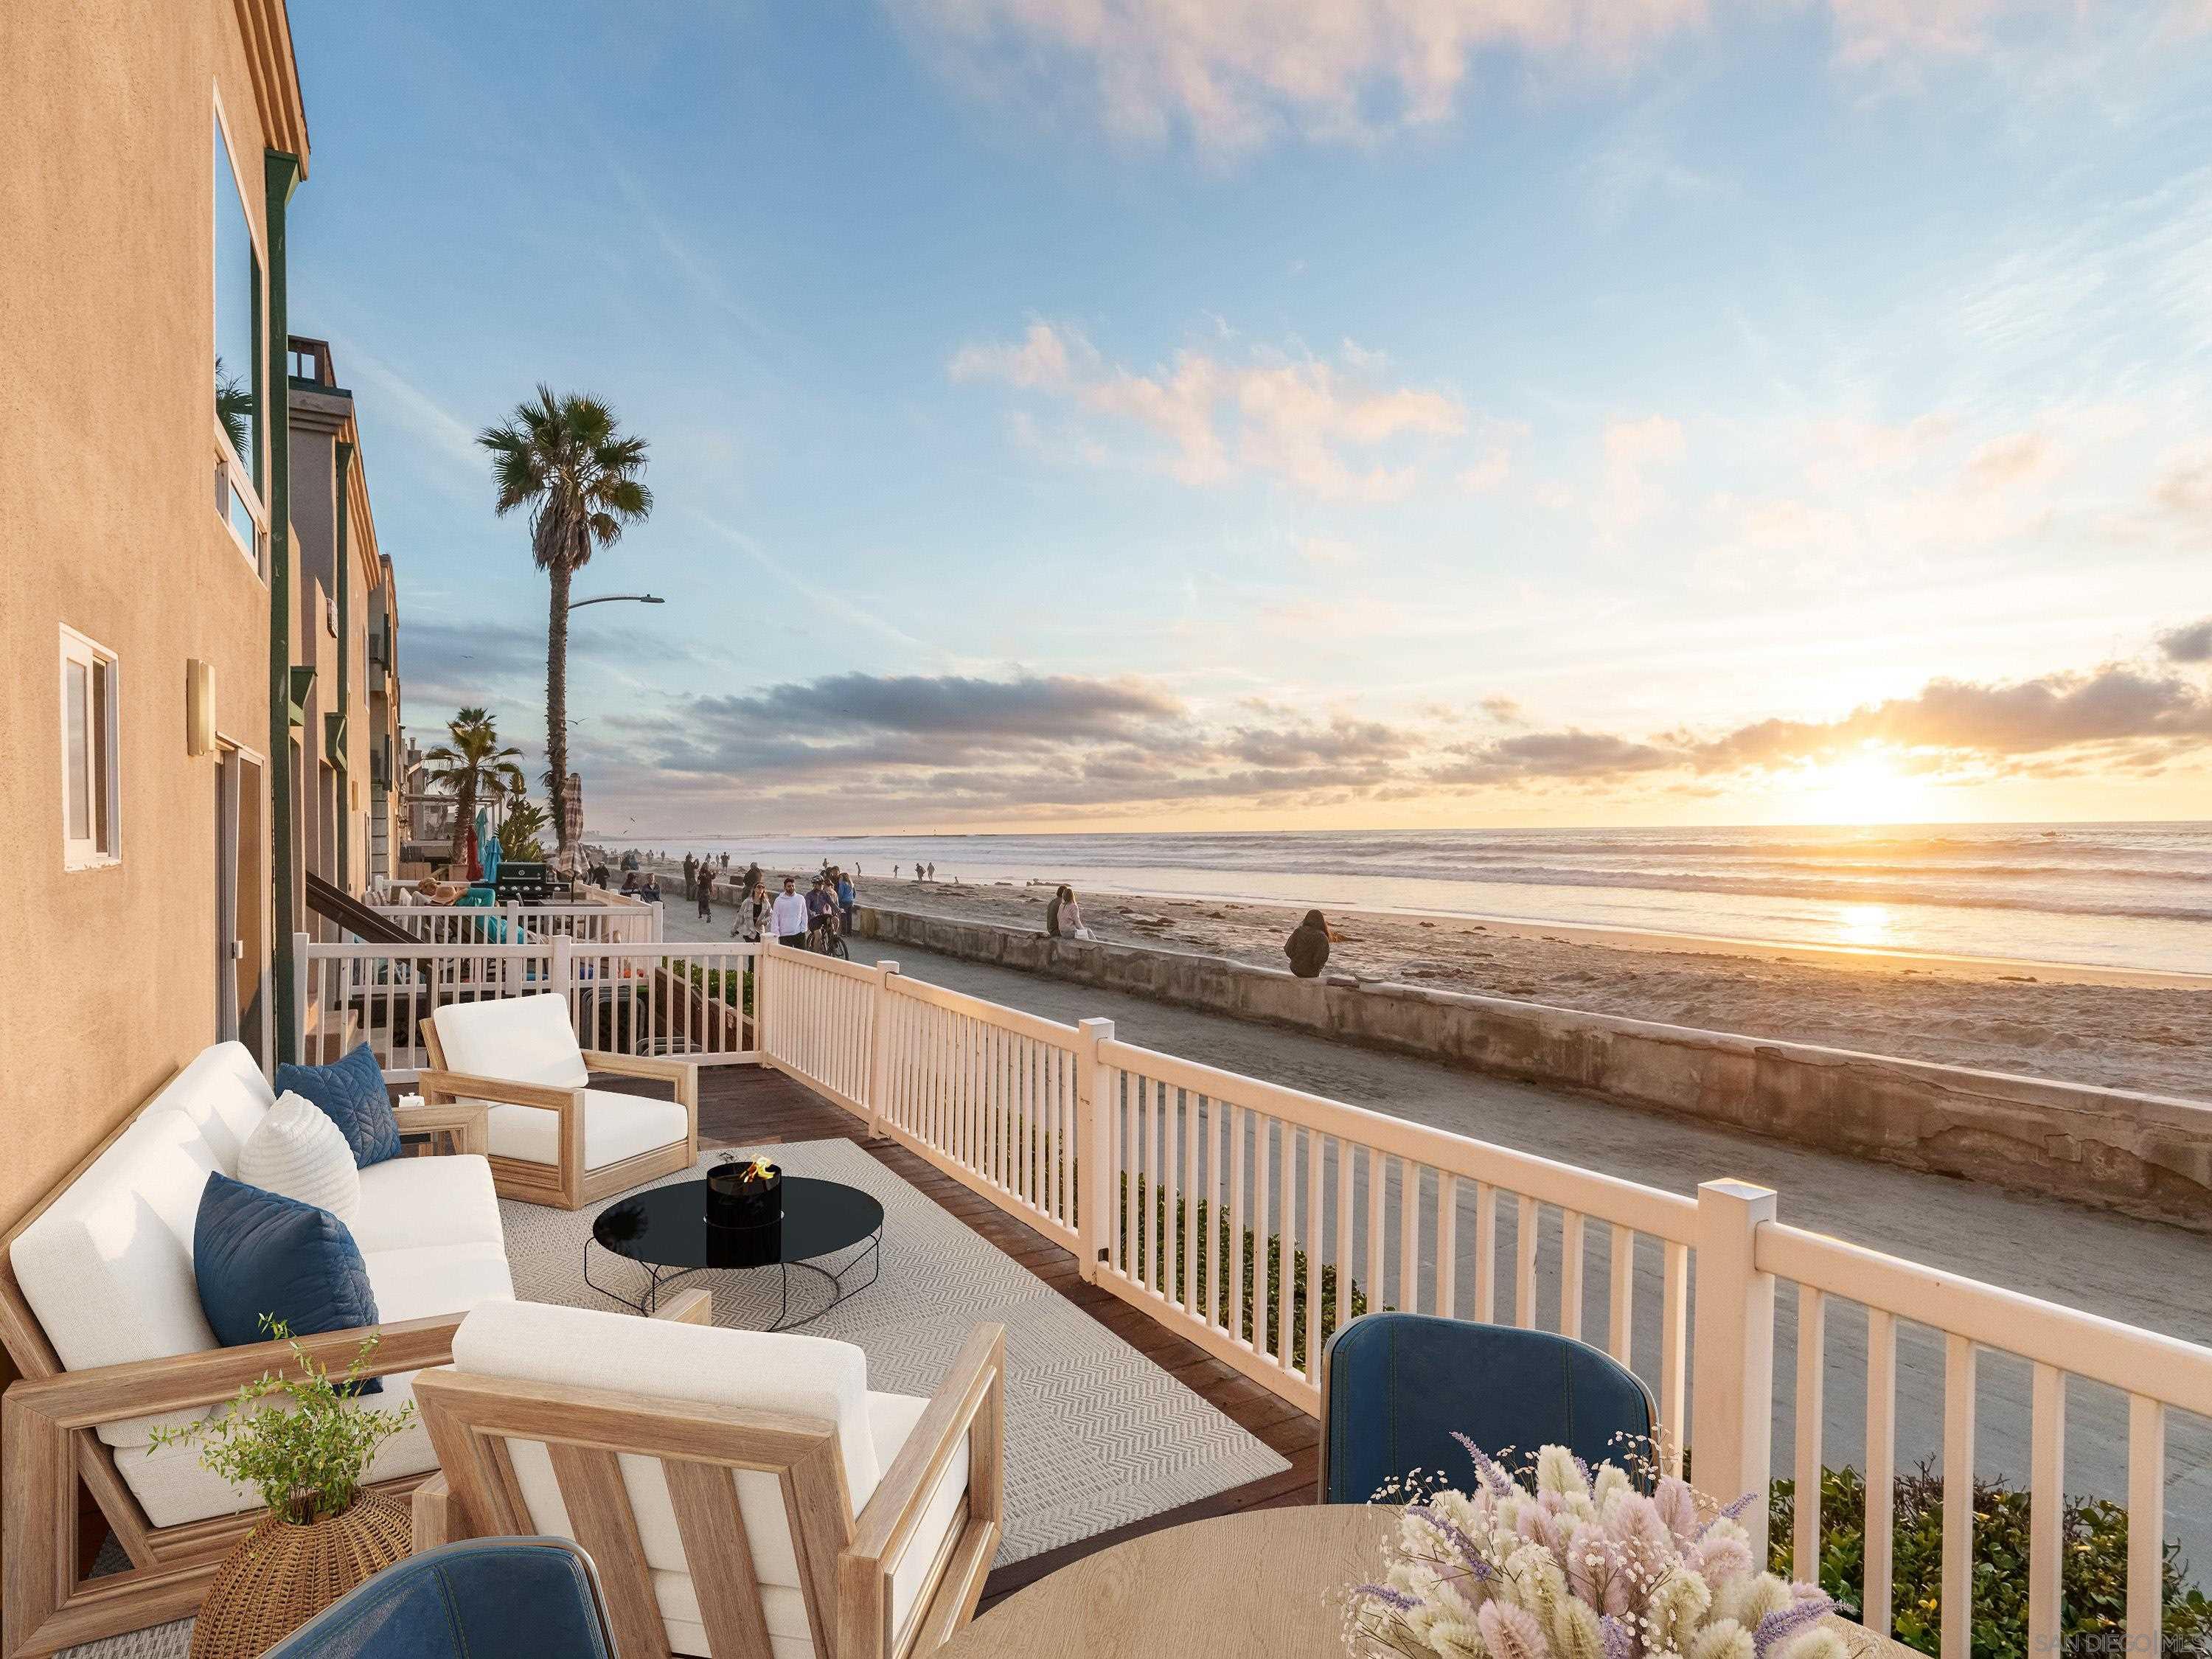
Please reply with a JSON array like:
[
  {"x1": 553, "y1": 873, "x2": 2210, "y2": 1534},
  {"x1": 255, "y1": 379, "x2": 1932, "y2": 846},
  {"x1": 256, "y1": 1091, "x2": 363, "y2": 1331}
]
[{"x1": 290, "y1": 0, "x2": 2212, "y2": 838}]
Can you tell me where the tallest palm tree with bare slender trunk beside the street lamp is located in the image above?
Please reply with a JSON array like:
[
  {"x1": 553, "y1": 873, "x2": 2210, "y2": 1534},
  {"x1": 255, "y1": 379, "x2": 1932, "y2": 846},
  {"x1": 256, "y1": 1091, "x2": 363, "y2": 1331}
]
[{"x1": 476, "y1": 383, "x2": 653, "y2": 865}]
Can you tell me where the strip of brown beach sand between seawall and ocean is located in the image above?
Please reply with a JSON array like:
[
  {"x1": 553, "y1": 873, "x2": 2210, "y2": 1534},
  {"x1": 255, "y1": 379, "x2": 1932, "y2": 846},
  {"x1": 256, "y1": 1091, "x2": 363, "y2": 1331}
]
[{"x1": 672, "y1": 872, "x2": 2212, "y2": 1102}]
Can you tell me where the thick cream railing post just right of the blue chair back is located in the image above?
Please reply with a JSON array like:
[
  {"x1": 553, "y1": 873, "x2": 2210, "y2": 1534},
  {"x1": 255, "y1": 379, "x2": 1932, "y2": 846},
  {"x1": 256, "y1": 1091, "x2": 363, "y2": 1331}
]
[{"x1": 1690, "y1": 1181, "x2": 1803, "y2": 1562}]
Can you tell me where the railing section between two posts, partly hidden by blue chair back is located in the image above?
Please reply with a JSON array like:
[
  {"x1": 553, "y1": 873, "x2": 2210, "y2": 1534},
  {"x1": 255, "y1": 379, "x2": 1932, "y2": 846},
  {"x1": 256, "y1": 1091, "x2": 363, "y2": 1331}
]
[{"x1": 1086, "y1": 1040, "x2": 1699, "y2": 1464}]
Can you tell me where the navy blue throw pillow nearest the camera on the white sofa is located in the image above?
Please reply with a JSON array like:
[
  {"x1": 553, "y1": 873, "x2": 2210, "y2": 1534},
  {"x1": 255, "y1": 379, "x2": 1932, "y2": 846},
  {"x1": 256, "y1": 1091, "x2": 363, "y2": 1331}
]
[{"x1": 192, "y1": 1170, "x2": 383, "y2": 1394}]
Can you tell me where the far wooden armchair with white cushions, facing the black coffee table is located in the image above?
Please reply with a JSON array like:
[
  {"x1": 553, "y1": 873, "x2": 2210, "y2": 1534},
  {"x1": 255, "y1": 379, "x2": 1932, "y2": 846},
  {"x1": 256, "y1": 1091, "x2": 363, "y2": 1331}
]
[{"x1": 416, "y1": 993, "x2": 699, "y2": 1210}]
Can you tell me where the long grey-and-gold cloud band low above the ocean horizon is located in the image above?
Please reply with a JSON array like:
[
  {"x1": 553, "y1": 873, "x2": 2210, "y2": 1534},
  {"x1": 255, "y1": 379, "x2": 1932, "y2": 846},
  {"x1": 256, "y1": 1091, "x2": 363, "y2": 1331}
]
[{"x1": 580, "y1": 617, "x2": 2212, "y2": 827}]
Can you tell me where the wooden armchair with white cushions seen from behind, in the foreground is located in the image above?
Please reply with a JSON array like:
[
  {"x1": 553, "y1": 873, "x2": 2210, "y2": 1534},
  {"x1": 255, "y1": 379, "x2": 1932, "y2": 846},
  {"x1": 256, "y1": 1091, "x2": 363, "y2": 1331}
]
[{"x1": 416, "y1": 1303, "x2": 1006, "y2": 1659}]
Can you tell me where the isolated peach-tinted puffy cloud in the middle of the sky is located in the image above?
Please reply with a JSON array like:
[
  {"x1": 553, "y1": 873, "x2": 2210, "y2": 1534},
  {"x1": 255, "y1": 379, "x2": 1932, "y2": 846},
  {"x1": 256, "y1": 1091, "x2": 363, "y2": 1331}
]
[{"x1": 947, "y1": 323, "x2": 1469, "y2": 500}]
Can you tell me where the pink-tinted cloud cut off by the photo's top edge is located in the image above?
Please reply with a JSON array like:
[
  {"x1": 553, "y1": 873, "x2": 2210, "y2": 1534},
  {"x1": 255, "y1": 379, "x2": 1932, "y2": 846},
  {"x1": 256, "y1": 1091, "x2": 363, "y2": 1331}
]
[{"x1": 891, "y1": 0, "x2": 2070, "y2": 155}]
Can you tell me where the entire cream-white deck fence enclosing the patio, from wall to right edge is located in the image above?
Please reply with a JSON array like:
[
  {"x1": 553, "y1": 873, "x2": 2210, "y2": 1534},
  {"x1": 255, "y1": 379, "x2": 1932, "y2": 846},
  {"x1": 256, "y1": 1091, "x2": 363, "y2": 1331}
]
[{"x1": 301, "y1": 938, "x2": 2212, "y2": 1659}]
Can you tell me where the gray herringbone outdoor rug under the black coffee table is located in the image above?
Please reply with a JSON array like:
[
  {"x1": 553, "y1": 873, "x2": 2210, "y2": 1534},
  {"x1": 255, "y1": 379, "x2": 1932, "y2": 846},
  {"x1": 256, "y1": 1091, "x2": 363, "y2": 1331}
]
[{"x1": 71, "y1": 1141, "x2": 1290, "y2": 1659}]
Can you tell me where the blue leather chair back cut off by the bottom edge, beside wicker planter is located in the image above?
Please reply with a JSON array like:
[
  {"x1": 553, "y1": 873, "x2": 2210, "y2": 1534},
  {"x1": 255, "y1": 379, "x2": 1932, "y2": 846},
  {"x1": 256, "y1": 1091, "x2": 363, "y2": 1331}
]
[{"x1": 263, "y1": 1537, "x2": 615, "y2": 1659}]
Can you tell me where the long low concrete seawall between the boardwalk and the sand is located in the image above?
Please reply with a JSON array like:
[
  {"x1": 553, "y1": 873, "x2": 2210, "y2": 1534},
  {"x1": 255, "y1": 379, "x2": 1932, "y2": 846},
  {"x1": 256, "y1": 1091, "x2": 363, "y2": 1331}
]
[{"x1": 858, "y1": 907, "x2": 2212, "y2": 1232}]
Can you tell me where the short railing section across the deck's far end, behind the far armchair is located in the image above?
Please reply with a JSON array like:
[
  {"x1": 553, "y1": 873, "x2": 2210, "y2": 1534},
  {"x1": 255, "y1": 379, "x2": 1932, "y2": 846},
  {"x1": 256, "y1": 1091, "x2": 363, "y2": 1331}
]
[{"x1": 294, "y1": 933, "x2": 761, "y2": 1082}]
